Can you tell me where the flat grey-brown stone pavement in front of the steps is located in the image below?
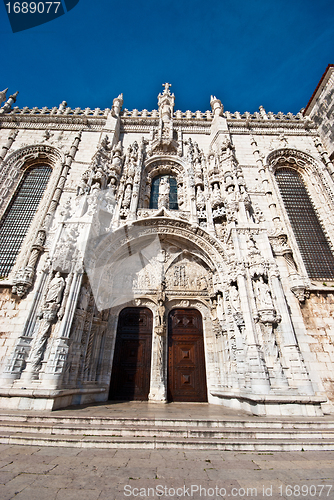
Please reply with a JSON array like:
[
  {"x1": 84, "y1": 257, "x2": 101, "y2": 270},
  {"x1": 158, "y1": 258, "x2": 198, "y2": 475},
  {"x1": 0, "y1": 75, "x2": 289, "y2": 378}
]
[{"x1": 0, "y1": 445, "x2": 334, "y2": 500}]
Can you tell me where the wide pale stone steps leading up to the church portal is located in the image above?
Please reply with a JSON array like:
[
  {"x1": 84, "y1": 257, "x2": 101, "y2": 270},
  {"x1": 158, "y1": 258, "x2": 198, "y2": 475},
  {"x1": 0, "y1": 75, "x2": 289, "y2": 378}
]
[{"x1": 0, "y1": 414, "x2": 334, "y2": 451}]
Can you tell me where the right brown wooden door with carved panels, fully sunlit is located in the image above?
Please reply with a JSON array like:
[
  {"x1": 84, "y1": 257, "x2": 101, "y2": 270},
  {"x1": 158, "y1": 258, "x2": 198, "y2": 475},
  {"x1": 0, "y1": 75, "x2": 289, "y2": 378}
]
[{"x1": 167, "y1": 309, "x2": 208, "y2": 402}]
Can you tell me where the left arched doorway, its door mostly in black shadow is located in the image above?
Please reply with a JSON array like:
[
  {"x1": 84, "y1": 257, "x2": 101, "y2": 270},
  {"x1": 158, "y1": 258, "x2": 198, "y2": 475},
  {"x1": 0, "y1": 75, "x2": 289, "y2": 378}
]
[{"x1": 109, "y1": 307, "x2": 153, "y2": 401}]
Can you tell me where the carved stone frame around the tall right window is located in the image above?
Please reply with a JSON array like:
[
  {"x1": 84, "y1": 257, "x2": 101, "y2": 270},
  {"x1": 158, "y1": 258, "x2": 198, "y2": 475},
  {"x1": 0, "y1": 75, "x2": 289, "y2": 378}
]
[{"x1": 267, "y1": 148, "x2": 334, "y2": 281}]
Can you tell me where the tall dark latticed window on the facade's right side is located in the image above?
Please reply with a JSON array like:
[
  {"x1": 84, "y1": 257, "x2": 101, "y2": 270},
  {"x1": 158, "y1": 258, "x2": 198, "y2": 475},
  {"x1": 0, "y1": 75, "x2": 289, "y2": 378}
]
[{"x1": 275, "y1": 168, "x2": 334, "y2": 280}]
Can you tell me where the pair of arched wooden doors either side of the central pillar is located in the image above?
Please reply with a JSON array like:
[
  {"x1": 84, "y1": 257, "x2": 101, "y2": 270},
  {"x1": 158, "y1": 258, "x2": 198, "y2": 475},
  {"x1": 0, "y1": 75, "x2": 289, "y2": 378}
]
[{"x1": 109, "y1": 307, "x2": 207, "y2": 402}]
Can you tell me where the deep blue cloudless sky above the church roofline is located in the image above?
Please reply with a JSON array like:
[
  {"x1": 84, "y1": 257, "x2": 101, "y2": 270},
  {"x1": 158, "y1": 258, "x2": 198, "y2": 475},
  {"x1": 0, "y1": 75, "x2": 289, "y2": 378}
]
[{"x1": 0, "y1": 0, "x2": 334, "y2": 113}]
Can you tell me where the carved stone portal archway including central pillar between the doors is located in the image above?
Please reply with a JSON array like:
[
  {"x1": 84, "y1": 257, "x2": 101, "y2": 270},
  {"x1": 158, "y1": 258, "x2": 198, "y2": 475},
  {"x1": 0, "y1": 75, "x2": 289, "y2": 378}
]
[{"x1": 83, "y1": 217, "x2": 227, "y2": 402}]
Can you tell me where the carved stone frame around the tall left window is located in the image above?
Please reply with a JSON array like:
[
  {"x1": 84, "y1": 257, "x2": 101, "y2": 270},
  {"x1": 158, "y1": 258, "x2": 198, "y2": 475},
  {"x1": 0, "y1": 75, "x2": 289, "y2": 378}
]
[{"x1": 0, "y1": 145, "x2": 65, "y2": 285}]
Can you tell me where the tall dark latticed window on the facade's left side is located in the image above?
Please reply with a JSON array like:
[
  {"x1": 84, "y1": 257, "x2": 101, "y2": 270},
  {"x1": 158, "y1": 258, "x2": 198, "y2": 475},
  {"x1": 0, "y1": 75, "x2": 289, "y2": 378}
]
[{"x1": 0, "y1": 166, "x2": 52, "y2": 278}]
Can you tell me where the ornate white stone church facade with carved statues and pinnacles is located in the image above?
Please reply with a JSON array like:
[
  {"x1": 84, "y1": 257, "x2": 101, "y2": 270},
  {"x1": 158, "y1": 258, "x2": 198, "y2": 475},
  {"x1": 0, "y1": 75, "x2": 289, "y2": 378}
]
[{"x1": 0, "y1": 76, "x2": 334, "y2": 416}]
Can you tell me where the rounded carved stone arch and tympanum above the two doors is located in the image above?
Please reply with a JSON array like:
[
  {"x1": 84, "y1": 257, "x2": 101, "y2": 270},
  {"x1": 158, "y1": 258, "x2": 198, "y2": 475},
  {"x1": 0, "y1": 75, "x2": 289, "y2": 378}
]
[{"x1": 85, "y1": 217, "x2": 228, "y2": 310}]
